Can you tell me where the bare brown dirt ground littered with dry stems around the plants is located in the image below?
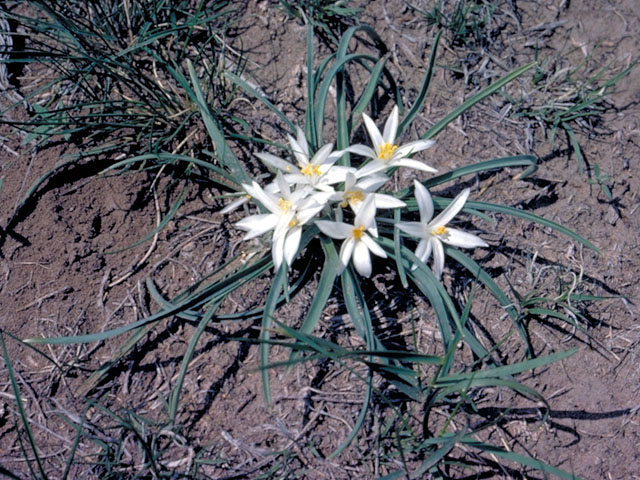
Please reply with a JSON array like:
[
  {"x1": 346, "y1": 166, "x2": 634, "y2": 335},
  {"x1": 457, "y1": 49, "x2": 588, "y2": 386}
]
[{"x1": 0, "y1": 0, "x2": 640, "y2": 480}]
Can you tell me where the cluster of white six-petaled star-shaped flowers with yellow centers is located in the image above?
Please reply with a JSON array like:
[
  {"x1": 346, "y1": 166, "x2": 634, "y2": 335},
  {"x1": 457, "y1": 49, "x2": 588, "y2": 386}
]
[{"x1": 222, "y1": 107, "x2": 487, "y2": 277}]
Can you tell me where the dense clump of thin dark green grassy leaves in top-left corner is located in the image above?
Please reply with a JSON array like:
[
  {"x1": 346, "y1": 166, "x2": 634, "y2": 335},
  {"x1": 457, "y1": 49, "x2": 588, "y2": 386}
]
[{"x1": 4, "y1": 0, "x2": 242, "y2": 158}]
